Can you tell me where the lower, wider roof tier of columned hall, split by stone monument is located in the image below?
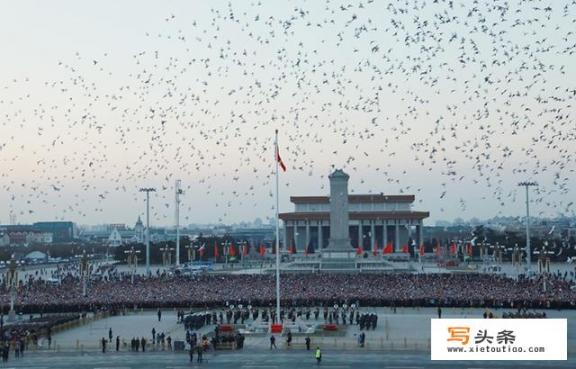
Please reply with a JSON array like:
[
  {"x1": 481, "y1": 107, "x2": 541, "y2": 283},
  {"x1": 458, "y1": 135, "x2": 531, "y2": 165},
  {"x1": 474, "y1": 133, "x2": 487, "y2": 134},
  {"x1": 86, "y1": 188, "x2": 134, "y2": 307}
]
[{"x1": 279, "y1": 211, "x2": 430, "y2": 221}]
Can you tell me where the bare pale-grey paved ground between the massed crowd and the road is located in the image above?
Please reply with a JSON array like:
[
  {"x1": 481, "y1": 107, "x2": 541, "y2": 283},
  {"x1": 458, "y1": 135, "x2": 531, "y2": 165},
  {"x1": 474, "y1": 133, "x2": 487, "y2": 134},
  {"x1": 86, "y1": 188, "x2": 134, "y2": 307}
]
[{"x1": 47, "y1": 308, "x2": 576, "y2": 352}]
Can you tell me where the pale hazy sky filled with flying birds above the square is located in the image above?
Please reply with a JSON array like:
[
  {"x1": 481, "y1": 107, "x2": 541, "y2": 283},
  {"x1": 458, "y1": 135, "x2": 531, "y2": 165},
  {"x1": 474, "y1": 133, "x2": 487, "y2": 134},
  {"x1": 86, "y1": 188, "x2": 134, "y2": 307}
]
[{"x1": 0, "y1": 0, "x2": 576, "y2": 225}]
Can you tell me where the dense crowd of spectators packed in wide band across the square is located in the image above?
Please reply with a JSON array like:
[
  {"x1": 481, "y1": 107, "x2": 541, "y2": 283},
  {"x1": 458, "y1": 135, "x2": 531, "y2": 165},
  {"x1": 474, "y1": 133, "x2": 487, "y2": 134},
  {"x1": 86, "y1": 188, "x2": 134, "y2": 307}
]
[{"x1": 0, "y1": 273, "x2": 576, "y2": 312}]
